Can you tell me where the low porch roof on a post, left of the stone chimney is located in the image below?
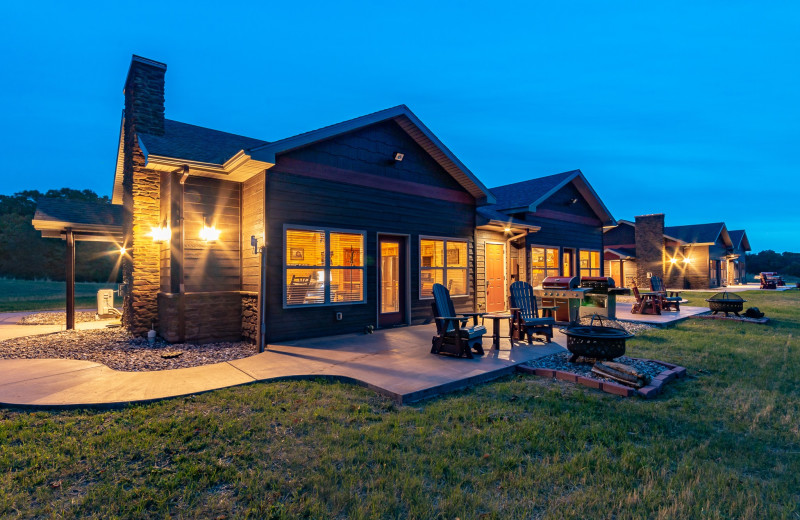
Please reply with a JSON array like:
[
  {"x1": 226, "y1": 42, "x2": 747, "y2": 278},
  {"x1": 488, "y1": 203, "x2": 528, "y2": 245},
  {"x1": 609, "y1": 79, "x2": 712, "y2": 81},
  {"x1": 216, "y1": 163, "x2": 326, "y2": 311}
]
[{"x1": 33, "y1": 198, "x2": 122, "y2": 242}]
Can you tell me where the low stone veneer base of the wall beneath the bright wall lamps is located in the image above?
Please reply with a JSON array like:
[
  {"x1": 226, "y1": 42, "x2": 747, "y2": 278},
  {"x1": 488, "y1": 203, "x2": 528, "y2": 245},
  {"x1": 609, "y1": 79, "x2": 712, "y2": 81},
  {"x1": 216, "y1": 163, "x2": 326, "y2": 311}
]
[{"x1": 158, "y1": 291, "x2": 243, "y2": 343}]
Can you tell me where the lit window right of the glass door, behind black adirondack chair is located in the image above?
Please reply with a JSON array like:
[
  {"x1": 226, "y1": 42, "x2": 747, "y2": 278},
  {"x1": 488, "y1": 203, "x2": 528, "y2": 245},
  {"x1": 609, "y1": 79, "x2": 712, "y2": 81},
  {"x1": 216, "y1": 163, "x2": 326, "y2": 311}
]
[{"x1": 419, "y1": 238, "x2": 468, "y2": 298}]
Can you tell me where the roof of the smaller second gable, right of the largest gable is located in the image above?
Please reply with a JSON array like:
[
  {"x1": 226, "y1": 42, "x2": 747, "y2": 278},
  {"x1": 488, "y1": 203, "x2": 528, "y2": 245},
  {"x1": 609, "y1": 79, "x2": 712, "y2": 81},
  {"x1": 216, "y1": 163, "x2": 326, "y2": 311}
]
[{"x1": 491, "y1": 170, "x2": 616, "y2": 226}]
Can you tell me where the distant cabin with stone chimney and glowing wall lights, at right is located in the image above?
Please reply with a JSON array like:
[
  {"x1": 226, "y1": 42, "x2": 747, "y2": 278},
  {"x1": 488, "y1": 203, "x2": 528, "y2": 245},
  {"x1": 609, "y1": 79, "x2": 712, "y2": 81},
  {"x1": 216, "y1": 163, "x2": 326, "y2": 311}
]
[{"x1": 604, "y1": 213, "x2": 749, "y2": 289}]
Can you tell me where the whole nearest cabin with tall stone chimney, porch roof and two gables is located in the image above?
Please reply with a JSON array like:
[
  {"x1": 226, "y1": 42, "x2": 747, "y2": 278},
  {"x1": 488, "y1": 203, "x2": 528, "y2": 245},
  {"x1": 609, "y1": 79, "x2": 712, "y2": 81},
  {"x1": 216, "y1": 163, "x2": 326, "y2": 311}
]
[{"x1": 34, "y1": 56, "x2": 616, "y2": 347}]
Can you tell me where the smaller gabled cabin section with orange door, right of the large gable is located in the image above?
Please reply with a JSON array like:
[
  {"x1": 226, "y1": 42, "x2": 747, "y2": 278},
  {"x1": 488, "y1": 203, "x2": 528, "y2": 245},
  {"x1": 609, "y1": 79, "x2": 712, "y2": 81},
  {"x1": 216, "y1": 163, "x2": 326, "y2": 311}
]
[{"x1": 475, "y1": 170, "x2": 616, "y2": 312}]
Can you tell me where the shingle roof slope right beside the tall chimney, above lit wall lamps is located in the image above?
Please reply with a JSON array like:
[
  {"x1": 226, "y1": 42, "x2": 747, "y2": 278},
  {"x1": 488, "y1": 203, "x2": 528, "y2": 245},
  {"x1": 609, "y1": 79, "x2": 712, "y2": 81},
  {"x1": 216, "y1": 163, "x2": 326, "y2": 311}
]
[{"x1": 139, "y1": 119, "x2": 269, "y2": 164}]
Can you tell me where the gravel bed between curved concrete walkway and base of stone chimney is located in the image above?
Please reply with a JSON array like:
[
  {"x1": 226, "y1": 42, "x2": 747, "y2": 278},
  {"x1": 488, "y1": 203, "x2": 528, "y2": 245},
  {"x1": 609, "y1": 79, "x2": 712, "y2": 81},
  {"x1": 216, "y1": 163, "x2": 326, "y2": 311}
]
[{"x1": 0, "y1": 328, "x2": 258, "y2": 372}]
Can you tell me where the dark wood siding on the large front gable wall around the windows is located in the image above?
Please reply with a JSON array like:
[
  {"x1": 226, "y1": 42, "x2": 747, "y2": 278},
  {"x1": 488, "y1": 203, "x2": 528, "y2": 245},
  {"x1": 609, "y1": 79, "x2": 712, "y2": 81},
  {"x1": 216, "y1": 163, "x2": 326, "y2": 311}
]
[{"x1": 266, "y1": 122, "x2": 475, "y2": 342}]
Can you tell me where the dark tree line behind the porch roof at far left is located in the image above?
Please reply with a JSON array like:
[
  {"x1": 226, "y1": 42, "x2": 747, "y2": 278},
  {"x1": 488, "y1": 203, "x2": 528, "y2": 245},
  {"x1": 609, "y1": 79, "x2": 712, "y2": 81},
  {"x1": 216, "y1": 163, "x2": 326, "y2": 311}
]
[{"x1": 0, "y1": 188, "x2": 122, "y2": 282}]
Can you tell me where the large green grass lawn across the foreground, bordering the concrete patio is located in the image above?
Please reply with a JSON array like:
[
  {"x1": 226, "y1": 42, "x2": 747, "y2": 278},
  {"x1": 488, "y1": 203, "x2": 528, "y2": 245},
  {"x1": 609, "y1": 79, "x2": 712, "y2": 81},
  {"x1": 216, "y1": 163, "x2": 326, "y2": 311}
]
[{"x1": 0, "y1": 291, "x2": 800, "y2": 519}]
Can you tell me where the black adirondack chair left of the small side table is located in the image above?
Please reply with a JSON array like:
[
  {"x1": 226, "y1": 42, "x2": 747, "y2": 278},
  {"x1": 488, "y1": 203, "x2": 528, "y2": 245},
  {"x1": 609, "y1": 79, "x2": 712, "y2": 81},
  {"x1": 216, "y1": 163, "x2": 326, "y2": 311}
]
[{"x1": 431, "y1": 283, "x2": 486, "y2": 359}]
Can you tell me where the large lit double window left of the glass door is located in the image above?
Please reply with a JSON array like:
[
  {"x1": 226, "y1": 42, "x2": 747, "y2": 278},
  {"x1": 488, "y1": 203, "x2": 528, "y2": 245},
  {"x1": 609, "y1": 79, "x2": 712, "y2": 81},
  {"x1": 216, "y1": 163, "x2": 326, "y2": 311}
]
[{"x1": 284, "y1": 228, "x2": 364, "y2": 306}]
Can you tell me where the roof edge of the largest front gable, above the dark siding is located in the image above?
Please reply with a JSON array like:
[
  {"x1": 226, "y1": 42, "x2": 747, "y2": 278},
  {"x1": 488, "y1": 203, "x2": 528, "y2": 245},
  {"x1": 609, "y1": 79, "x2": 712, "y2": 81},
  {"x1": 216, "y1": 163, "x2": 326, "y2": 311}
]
[{"x1": 247, "y1": 105, "x2": 495, "y2": 204}]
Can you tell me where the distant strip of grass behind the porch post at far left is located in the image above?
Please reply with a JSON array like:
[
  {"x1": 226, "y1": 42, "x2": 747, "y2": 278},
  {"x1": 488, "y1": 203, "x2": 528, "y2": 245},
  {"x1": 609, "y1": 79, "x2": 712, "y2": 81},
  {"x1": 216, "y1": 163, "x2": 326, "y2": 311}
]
[{"x1": 0, "y1": 278, "x2": 121, "y2": 312}]
